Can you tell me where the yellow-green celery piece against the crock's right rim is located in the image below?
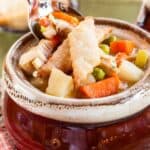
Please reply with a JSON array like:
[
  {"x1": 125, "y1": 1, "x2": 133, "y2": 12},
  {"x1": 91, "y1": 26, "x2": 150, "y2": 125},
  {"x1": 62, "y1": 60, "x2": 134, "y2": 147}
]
[{"x1": 135, "y1": 50, "x2": 149, "y2": 68}]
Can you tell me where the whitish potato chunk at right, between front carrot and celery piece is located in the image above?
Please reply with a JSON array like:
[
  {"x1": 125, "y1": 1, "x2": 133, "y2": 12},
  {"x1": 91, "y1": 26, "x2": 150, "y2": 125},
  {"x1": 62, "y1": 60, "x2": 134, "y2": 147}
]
[{"x1": 119, "y1": 60, "x2": 144, "y2": 83}]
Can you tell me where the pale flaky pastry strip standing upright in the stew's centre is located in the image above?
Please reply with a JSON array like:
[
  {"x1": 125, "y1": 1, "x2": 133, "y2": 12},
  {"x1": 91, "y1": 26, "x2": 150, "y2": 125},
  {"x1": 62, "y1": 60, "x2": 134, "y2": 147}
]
[{"x1": 69, "y1": 18, "x2": 100, "y2": 86}]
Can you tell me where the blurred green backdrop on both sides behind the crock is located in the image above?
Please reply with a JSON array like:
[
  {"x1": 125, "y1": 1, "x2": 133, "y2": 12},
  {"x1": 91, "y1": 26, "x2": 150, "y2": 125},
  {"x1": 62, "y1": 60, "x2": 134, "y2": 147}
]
[{"x1": 0, "y1": 0, "x2": 141, "y2": 75}]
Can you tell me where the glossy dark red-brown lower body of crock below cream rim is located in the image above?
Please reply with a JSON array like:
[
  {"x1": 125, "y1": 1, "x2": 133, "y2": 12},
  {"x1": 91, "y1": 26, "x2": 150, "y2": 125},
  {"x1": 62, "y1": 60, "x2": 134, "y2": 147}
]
[{"x1": 4, "y1": 94, "x2": 150, "y2": 150}]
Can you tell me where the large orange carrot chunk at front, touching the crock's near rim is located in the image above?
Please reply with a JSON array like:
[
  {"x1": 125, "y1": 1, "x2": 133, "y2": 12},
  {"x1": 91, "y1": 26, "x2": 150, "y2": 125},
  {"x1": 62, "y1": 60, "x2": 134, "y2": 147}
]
[{"x1": 79, "y1": 75, "x2": 120, "y2": 98}]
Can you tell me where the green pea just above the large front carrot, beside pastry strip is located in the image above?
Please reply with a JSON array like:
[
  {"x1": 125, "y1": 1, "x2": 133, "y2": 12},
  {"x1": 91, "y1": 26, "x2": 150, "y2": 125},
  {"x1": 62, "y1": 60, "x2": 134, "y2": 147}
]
[{"x1": 93, "y1": 68, "x2": 106, "y2": 81}]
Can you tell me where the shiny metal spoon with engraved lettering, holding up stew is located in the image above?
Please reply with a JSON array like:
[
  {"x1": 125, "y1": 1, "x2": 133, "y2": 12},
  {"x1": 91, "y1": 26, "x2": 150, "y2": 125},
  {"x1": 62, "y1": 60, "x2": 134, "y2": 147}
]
[{"x1": 28, "y1": 0, "x2": 83, "y2": 40}]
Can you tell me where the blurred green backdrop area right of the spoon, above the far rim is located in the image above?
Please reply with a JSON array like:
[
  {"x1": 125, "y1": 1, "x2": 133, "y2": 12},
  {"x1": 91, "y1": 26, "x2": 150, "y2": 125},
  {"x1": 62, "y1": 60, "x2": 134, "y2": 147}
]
[{"x1": 79, "y1": 0, "x2": 142, "y2": 22}]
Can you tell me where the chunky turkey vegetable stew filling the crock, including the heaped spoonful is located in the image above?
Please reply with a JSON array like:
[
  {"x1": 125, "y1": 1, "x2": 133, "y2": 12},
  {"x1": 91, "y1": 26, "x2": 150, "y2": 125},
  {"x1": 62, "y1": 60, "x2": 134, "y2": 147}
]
[{"x1": 19, "y1": 16, "x2": 149, "y2": 98}]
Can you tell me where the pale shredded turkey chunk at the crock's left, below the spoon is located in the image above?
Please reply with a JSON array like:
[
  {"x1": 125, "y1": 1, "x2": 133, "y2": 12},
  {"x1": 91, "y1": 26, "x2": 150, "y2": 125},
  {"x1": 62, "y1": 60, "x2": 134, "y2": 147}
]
[{"x1": 19, "y1": 40, "x2": 54, "y2": 74}]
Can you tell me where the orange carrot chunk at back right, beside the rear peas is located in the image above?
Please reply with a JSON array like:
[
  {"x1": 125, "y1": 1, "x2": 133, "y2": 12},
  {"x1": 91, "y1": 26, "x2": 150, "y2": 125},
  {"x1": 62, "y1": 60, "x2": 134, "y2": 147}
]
[{"x1": 110, "y1": 40, "x2": 135, "y2": 54}]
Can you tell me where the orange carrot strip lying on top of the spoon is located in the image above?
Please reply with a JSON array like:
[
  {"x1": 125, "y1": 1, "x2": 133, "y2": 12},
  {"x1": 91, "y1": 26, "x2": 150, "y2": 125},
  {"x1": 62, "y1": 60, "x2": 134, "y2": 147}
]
[{"x1": 53, "y1": 11, "x2": 79, "y2": 25}]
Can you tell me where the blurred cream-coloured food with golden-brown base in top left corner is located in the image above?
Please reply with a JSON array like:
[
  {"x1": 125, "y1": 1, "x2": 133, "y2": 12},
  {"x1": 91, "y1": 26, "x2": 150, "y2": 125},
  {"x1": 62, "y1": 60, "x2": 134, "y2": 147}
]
[{"x1": 0, "y1": 0, "x2": 28, "y2": 30}]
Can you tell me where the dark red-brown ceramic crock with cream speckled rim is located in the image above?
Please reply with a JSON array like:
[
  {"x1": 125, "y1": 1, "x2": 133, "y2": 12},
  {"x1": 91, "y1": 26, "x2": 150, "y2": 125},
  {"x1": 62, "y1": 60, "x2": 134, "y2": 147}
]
[{"x1": 3, "y1": 18, "x2": 150, "y2": 150}]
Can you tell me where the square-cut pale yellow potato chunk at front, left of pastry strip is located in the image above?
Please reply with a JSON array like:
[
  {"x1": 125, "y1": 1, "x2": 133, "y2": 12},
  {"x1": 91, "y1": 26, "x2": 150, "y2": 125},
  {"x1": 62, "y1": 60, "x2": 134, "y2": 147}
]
[{"x1": 46, "y1": 68, "x2": 74, "y2": 97}]
